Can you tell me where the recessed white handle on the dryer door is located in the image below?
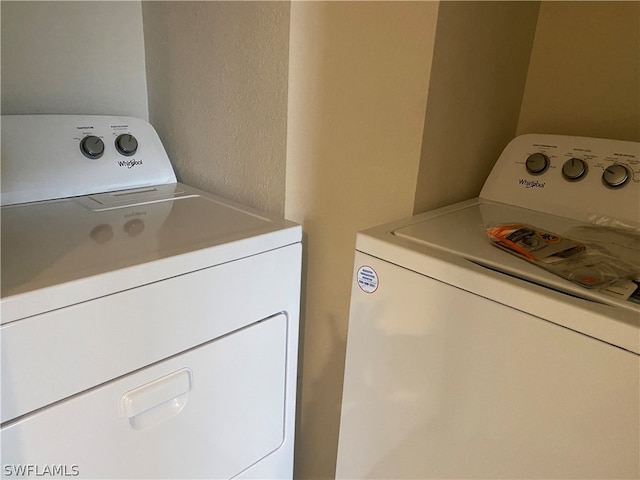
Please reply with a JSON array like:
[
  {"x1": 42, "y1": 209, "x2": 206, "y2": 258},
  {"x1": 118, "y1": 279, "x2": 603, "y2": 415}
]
[{"x1": 120, "y1": 368, "x2": 193, "y2": 430}]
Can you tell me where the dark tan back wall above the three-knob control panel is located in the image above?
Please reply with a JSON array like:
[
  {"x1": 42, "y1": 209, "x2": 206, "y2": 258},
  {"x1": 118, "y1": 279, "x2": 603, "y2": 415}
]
[{"x1": 518, "y1": 1, "x2": 640, "y2": 142}]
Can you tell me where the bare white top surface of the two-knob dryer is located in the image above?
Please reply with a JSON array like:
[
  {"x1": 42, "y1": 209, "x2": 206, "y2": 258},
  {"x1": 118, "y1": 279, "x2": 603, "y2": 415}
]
[{"x1": 2, "y1": 184, "x2": 301, "y2": 323}]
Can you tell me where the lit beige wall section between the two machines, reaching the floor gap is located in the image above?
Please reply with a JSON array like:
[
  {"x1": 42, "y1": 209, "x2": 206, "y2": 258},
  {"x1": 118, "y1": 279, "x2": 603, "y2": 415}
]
[{"x1": 285, "y1": 2, "x2": 438, "y2": 479}]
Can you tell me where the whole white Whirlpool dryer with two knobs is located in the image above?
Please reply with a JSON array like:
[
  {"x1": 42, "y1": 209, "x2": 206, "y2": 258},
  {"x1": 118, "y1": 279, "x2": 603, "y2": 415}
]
[{"x1": 0, "y1": 115, "x2": 301, "y2": 479}]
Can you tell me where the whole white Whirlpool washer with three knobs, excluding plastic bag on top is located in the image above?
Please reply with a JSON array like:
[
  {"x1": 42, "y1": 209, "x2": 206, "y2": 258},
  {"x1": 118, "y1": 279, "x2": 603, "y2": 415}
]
[{"x1": 337, "y1": 135, "x2": 640, "y2": 479}]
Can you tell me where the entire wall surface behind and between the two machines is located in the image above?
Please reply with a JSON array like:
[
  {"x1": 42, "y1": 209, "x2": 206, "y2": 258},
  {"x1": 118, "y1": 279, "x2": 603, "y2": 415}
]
[{"x1": 2, "y1": 1, "x2": 640, "y2": 479}]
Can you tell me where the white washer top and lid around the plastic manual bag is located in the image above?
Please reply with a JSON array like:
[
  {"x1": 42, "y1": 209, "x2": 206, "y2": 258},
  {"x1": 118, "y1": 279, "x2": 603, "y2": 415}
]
[{"x1": 356, "y1": 199, "x2": 640, "y2": 354}]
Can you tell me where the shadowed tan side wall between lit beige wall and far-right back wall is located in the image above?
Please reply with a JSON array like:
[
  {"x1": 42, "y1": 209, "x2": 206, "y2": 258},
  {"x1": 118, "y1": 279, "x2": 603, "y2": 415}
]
[{"x1": 414, "y1": 1, "x2": 539, "y2": 213}]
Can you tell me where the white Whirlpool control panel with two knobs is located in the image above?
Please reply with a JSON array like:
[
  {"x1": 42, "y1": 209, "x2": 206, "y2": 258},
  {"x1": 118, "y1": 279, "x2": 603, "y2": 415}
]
[{"x1": 2, "y1": 115, "x2": 176, "y2": 205}]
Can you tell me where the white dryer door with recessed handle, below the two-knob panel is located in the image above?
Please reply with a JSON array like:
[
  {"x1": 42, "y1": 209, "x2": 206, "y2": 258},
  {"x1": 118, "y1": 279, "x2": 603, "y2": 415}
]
[{"x1": 2, "y1": 314, "x2": 288, "y2": 479}]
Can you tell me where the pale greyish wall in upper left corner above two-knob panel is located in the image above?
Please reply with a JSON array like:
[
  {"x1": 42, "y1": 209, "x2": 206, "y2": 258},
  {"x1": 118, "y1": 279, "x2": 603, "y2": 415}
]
[{"x1": 1, "y1": 1, "x2": 148, "y2": 119}]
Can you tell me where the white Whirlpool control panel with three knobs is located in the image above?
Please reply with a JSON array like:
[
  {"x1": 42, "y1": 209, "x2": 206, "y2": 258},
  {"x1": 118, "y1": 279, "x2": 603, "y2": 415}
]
[{"x1": 480, "y1": 134, "x2": 640, "y2": 225}]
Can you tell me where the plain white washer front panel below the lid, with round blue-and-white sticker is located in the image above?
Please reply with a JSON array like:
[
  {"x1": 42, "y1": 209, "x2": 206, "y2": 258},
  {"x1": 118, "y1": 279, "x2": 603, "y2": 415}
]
[{"x1": 336, "y1": 252, "x2": 640, "y2": 479}]
